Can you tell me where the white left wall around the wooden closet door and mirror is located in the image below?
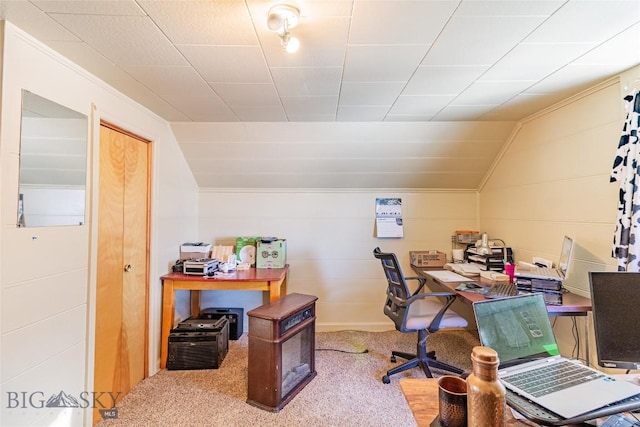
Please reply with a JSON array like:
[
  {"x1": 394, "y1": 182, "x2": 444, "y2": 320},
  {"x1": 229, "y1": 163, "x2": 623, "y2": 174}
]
[{"x1": 0, "y1": 23, "x2": 198, "y2": 426}]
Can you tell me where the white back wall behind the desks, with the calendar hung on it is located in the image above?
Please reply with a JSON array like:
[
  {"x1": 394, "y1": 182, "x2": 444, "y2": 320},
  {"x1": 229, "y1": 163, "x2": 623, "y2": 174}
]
[{"x1": 199, "y1": 189, "x2": 477, "y2": 331}]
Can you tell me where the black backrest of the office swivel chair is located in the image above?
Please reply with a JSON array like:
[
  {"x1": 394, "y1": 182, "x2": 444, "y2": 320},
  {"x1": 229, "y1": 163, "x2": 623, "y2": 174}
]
[{"x1": 373, "y1": 248, "x2": 411, "y2": 331}]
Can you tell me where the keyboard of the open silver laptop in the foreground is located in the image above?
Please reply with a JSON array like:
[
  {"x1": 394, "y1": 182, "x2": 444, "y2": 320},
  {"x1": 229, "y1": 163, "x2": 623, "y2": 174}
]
[{"x1": 501, "y1": 360, "x2": 605, "y2": 397}]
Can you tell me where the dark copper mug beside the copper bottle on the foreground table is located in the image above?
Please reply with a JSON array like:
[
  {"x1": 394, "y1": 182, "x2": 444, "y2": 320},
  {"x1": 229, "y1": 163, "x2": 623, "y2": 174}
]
[{"x1": 438, "y1": 375, "x2": 467, "y2": 427}]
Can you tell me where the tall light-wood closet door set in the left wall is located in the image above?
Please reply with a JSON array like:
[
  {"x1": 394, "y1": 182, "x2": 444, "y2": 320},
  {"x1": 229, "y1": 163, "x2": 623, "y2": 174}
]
[{"x1": 93, "y1": 124, "x2": 150, "y2": 423}]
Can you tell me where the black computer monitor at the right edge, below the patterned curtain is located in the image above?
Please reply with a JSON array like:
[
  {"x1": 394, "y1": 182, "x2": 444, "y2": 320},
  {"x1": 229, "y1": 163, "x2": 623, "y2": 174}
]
[{"x1": 589, "y1": 271, "x2": 640, "y2": 369}]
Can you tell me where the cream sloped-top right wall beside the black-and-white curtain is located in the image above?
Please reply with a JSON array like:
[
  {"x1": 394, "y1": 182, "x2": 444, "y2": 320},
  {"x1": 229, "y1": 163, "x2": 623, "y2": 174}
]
[{"x1": 480, "y1": 67, "x2": 640, "y2": 364}]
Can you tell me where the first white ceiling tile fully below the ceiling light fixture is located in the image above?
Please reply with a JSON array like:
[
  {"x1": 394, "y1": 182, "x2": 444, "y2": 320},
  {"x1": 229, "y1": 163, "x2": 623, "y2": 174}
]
[{"x1": 271, "y1": 67, "x2": 342, "y2": 97}]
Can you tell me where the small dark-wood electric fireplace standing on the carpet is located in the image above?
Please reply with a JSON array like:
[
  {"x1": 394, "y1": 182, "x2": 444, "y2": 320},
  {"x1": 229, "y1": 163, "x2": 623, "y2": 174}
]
[{"x1": 247, "y1": 293, "x2": 318, "y2": 412}]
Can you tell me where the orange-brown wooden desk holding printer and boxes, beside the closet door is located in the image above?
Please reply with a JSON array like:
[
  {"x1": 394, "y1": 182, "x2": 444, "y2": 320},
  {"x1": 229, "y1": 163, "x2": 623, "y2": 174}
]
[{"x1": 160, "y1": 264, "x2": 289, "y2": 369}]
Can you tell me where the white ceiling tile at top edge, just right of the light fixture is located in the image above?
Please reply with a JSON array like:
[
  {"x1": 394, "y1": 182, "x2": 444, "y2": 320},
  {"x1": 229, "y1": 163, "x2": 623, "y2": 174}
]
[{"x1": 349, "y1": 0, "x2": 458, "y2": 45}]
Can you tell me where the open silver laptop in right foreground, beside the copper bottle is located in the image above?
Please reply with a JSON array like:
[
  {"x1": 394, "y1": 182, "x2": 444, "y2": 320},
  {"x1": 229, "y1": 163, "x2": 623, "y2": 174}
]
[{"x1": 473, "y1": 294, "x2": 640, "y2": 418}]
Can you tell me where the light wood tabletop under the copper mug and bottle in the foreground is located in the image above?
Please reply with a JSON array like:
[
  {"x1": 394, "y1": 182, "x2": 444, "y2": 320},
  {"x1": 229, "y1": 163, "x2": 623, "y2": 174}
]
[{"x1": 400, "y1": 378, "x2": 537, "y2": 427}]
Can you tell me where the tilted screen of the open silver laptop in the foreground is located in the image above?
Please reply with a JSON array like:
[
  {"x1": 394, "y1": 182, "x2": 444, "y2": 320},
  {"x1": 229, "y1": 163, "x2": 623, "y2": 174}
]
[{"x1": 473, "y1": 294, "x2": 560, "y2": 367}]
